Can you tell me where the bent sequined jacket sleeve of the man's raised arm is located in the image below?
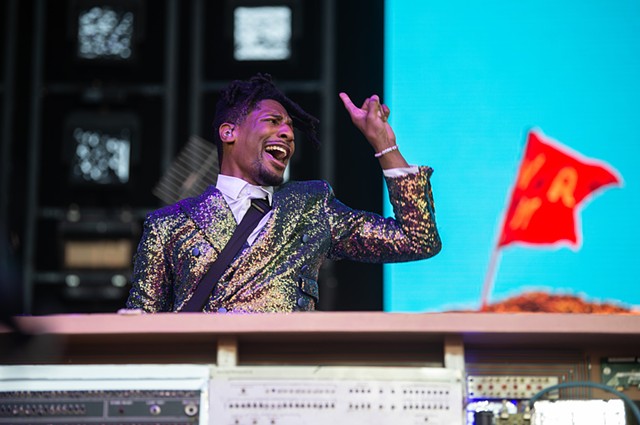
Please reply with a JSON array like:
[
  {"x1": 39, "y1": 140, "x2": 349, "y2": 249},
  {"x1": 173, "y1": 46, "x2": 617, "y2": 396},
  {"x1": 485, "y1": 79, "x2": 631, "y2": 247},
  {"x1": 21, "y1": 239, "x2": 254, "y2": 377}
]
[{"x1": 326, "y1": 167, "x2": 442, "y2": 263}]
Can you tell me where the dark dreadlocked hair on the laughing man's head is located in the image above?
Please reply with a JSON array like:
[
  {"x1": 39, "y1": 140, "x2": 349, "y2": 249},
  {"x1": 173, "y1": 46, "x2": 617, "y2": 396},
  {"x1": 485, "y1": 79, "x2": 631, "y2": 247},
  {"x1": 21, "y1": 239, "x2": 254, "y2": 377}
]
[{"x1": 213, "y1": 73, "x2": 320, "y2": 162}]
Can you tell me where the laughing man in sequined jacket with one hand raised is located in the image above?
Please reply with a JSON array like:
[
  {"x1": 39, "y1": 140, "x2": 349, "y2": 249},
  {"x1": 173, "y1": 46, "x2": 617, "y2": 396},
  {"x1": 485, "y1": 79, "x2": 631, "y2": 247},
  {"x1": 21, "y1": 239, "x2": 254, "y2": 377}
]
[{"x1": 127, "y1": 74, "x2": 441, "y2": 312}]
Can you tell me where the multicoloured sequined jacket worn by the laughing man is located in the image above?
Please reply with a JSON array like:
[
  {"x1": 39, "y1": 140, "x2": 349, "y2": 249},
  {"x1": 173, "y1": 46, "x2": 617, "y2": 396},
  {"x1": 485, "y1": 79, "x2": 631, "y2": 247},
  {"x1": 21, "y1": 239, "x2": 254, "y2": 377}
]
[{"x1": 127, "y1": 167, "x2": 441, "y2": 312}]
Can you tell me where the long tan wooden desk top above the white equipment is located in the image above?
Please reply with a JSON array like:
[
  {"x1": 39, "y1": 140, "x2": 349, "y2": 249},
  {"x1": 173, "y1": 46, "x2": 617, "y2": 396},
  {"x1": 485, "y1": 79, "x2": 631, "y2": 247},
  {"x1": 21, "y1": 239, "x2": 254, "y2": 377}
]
[{"x1": 4, "y1": 312, "x2": 640, "y2": 365}]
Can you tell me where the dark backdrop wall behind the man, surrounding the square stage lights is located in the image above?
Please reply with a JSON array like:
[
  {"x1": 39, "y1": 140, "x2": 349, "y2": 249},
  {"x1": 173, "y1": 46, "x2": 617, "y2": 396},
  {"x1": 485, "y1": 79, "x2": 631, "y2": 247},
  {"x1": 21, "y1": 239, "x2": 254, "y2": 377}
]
[{"x1": 0, "y1": 0, "x2": 384, "y2": 314}]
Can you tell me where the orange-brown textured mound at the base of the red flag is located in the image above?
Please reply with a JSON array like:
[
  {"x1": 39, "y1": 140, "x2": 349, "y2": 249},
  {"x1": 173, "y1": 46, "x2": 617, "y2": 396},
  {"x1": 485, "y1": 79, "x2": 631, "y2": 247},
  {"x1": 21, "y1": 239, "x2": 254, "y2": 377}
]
[{"x1": 482, "y1": 292, "x2": 640, "y2": 314}]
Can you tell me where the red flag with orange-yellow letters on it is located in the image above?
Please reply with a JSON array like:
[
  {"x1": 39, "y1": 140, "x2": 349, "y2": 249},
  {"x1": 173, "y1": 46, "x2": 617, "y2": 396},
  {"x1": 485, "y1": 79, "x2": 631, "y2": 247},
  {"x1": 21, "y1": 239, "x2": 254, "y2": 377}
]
[{"x1": 498, "y1": 131, "x2": 621, "y2": 249}]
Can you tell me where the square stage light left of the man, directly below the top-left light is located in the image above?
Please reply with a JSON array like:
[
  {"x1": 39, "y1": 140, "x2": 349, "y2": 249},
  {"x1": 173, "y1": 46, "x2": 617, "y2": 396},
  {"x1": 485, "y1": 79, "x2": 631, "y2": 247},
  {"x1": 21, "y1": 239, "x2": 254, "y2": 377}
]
[{"x1": 65, "y1": 112, "x2": 138, "y2": 186}]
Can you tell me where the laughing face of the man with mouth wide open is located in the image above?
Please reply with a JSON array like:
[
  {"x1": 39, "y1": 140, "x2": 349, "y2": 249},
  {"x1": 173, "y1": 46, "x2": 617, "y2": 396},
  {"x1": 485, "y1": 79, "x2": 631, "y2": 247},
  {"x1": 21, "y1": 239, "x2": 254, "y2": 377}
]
[{"x1": 221, "y1": 99, "x2": 295, "y2": 186}]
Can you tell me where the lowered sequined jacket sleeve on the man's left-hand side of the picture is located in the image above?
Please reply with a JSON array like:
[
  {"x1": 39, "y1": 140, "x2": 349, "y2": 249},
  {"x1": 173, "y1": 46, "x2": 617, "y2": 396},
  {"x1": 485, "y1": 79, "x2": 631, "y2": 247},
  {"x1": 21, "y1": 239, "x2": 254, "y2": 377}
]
[{"x1": 126, "y1": 215, "x2": 173, "y2": 313}]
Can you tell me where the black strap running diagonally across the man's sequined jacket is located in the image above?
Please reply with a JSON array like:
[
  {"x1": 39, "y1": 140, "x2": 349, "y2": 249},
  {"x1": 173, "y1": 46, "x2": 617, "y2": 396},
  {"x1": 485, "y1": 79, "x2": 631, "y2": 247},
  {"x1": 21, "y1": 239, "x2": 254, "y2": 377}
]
[{"x1": 180, "y1": 199, "x2": 271, "y2": 312}]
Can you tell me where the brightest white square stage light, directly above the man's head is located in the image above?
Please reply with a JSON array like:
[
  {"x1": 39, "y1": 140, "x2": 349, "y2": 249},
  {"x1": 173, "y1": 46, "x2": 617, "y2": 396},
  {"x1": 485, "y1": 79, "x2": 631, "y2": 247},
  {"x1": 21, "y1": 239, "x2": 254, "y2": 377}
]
[{"x1": 233, "y1": 5, "x2": 293, "y2": 61}]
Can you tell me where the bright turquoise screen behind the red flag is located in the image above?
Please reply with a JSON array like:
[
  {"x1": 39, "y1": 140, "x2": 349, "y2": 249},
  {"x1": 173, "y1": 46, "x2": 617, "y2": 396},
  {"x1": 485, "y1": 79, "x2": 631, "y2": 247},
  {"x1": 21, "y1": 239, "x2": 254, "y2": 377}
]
[{"x1": 383, "y1": 0, "x2": 640, "y2": 312}]
